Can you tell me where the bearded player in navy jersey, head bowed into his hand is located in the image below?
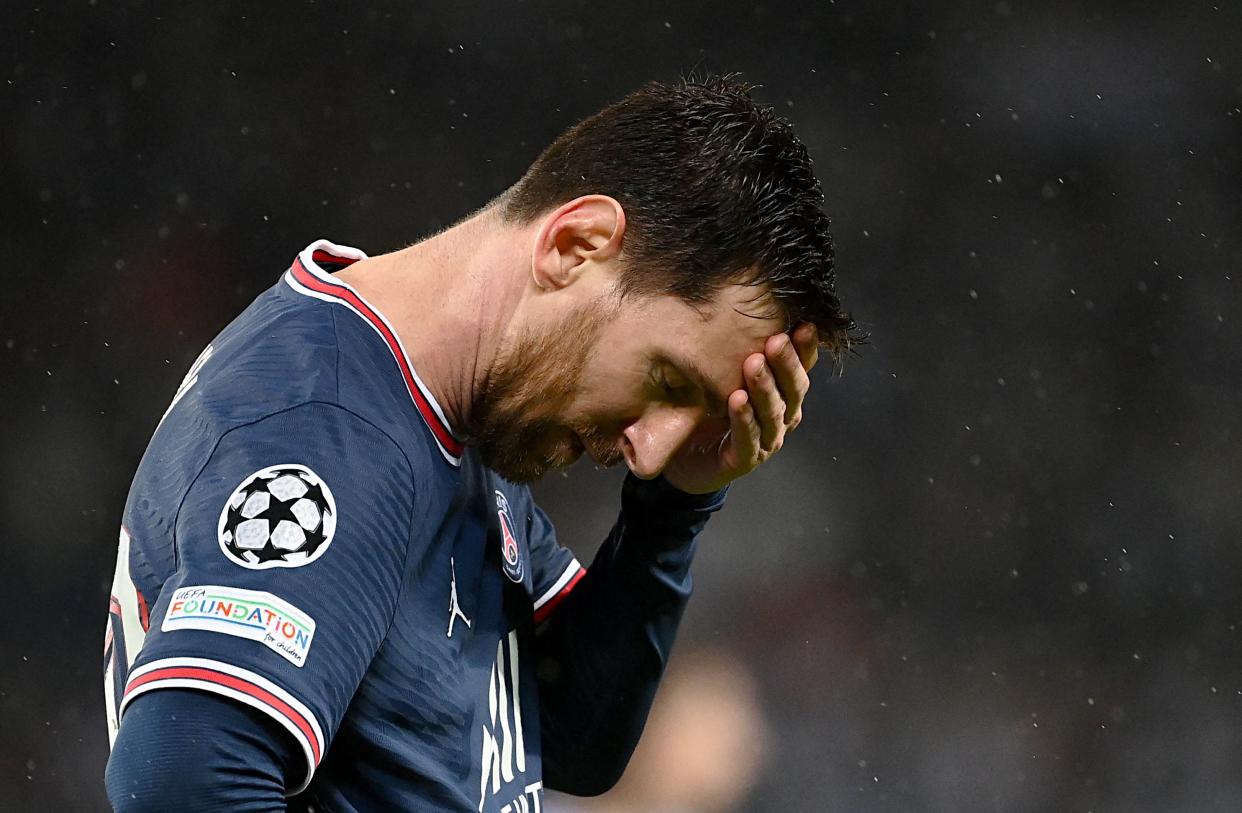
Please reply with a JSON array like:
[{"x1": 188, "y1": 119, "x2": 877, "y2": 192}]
[{"x1": 104, "y1": 77, "x2": 856, "y2": 813}]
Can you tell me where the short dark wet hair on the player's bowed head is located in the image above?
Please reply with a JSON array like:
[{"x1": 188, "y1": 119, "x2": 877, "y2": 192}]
[{"x1": 499, "y1": 74, "x2": 866, "y2": 362}]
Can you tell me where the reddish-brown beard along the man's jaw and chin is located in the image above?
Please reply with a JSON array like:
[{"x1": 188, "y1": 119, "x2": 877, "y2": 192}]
[{"x1": 469, "y1": 302, "x2": 623, "y2": 483}]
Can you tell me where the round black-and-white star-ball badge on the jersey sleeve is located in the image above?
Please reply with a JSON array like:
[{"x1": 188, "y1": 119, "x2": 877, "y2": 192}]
[{"x1": 219, "y1": 463, "x2": 337, "y2": 570}]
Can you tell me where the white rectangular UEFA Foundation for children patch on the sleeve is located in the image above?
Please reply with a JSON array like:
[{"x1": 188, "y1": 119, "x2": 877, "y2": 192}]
[{"x1": 160, "y1": 585, "x2": 314, "y2": 667}]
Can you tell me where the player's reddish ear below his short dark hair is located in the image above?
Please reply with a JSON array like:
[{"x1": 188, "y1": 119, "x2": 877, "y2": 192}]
[{"x1": 530, "y1": 195, "x2": 625, "y2": 289}]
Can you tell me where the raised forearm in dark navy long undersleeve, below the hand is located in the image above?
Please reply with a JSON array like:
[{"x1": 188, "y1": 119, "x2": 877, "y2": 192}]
[{"x1": 538, "y1": 475, "x2": 724, "y2": 796}]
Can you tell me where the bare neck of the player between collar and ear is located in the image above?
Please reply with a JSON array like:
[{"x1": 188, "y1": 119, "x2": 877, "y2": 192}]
[{"x1": 335, "y1": 210, "x2": 529, "y2": 434}]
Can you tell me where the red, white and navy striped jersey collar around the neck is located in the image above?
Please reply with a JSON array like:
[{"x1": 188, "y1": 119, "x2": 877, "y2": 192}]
[{"x1": 284, "y1": 240, "x2": 466, "y2": 465}]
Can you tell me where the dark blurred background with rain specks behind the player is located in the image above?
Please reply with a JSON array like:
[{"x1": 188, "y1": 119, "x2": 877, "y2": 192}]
[{"x1": 0, "y1": 0, "x2": 1242, "y2": 813}]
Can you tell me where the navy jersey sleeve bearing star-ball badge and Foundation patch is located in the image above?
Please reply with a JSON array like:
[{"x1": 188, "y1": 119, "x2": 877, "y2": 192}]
[{"x1": 120, "y1": 403, "x2": 414, "y2": 794}]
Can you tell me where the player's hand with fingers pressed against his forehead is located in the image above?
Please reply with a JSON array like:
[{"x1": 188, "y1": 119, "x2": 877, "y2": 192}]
[{"x1": 663, "y1": 324, "x2": 818, "y2": 494}]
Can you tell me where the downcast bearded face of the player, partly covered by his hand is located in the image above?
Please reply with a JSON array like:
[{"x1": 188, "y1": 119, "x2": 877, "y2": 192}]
[{"x1": 471, "y1": 285, "x2": 785, "y2": 483}]
